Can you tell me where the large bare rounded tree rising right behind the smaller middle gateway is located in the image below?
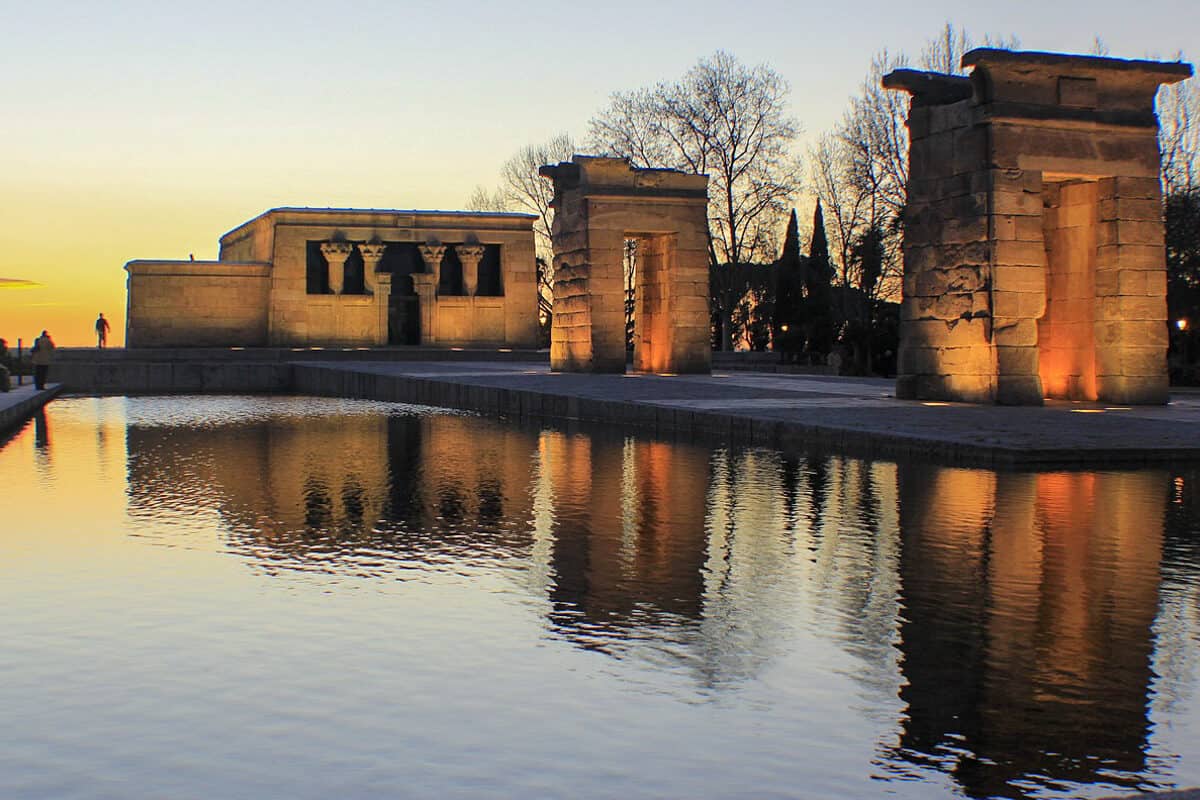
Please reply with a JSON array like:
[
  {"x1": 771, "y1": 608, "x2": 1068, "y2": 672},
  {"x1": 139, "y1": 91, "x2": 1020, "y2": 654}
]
[{"x1": 588, "y1": 50, "x2": 800, "y2": 349}]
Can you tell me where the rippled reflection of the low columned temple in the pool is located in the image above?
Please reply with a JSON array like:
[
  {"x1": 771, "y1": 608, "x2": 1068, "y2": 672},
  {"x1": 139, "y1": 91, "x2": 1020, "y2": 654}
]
[{"x1": 127, "y1": 413, "x2": 536, "y2": 573}]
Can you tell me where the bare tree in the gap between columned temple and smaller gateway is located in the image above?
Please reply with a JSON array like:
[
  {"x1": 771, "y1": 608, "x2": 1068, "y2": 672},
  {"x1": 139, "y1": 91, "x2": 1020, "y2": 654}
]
[{"x1": 467, "y1": 133, "x2": 575, "y2": 320}]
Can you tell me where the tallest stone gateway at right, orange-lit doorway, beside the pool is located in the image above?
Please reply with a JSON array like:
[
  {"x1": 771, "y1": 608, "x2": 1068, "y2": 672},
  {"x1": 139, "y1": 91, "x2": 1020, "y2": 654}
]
[{"x1": 883, "y1": 49, "x2": 1192, "y2": 404}]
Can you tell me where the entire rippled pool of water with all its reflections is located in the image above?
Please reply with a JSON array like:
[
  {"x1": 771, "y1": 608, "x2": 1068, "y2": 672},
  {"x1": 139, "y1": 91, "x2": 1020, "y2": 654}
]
[{"x1": 0, "y1": 397, "x2": 1200, "y2": 799}]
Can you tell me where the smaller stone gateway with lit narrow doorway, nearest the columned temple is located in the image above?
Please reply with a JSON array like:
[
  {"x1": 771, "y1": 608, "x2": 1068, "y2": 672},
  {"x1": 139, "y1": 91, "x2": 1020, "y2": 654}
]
[{"x1": 541, "y1": 156, "x2": 712, "y2": 373}]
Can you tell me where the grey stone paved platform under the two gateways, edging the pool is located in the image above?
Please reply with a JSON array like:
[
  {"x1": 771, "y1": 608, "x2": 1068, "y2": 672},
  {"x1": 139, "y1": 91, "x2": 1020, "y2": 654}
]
[{"x1": 296, "y1": 362, "x2": 1200, "y2": 467}]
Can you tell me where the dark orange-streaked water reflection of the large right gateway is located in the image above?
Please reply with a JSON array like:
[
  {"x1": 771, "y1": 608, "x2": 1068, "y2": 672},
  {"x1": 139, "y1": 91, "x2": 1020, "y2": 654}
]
[{"x1": 894, "y1": 465, "x2": 1169, "y2": 796}]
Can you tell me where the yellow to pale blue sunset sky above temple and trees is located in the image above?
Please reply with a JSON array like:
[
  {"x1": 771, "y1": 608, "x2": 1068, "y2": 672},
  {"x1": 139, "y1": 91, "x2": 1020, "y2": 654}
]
[{"x1": 0, "y1": 0, "x2": 1200, "y2": 345}]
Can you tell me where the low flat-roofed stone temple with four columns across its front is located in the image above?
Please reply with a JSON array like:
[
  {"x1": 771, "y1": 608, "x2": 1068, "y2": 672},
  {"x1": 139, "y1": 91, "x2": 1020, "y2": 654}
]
[{"x1": 125, "y1": 209, "x2": 538, "y2": 348}]
